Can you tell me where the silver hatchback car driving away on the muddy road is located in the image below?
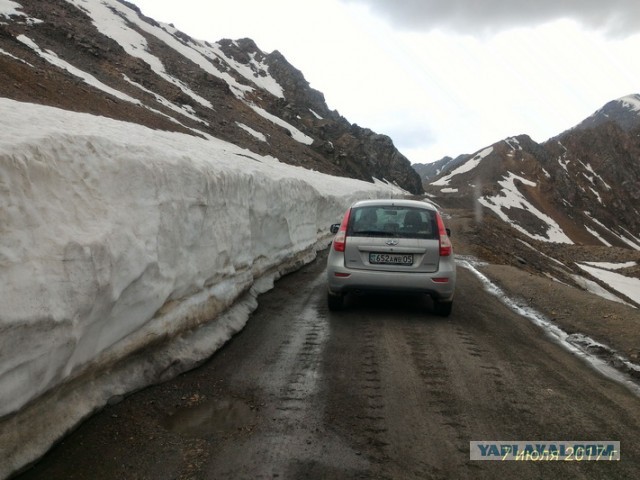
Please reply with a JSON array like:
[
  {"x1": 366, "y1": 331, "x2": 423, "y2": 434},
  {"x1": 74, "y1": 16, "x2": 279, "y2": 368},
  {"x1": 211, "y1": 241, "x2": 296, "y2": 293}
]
[{"x1": 327, "y1": 199, "x2": 456, "y2": 316}]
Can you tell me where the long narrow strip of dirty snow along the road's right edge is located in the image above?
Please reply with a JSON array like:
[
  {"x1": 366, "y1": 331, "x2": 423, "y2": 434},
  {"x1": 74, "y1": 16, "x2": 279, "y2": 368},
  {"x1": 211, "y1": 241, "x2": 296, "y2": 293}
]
[{"x1": 456, "y1": 257, "x2": 640, "y2": 395}]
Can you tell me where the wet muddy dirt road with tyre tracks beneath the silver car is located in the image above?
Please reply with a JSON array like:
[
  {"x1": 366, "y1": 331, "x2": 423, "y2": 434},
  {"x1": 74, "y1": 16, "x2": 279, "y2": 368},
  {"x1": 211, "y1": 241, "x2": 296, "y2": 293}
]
[{"x1": 17, "y1": 255, "x2": 640, "y2": 480}]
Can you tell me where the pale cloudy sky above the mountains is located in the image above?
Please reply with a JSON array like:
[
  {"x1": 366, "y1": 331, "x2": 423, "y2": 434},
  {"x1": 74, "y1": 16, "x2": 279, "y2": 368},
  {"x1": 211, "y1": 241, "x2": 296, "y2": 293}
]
[{"x1": 132, "y1": 0, "x2": 640, "y2": 163}]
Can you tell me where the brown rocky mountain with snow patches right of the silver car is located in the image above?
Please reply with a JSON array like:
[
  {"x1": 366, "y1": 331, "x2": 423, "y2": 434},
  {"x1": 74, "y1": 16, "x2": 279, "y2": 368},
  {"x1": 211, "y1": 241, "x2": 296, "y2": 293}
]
[{"x1": 424, "y1": 95, "x2": 640, "y2": 306}]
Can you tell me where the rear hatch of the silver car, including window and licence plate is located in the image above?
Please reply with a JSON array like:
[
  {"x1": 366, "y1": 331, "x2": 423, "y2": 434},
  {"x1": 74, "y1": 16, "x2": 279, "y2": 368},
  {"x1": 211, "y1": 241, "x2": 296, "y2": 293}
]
[{"x1": 344, "y1": 206, "x2": 440, "y2": 273}]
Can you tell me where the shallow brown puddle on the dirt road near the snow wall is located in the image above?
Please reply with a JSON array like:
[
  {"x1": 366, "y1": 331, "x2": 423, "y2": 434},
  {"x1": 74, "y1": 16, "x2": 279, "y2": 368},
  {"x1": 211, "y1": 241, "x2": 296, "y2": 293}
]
[{"x1": 163, "y1": 399, "x2": 257, "y2": 437}]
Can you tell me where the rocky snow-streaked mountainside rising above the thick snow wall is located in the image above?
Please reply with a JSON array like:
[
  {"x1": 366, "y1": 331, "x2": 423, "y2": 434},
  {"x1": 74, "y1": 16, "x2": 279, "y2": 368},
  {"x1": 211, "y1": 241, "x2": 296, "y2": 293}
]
[{"x1": 0, "y1": 0, "x2": 422, "y2": 193}]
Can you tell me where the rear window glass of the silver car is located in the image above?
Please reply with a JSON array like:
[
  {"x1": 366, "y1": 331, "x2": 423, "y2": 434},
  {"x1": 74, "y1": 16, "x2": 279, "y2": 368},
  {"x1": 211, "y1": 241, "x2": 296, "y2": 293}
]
[{"x1": 347, "y1": 206, "x2": 438, "y2": 239}]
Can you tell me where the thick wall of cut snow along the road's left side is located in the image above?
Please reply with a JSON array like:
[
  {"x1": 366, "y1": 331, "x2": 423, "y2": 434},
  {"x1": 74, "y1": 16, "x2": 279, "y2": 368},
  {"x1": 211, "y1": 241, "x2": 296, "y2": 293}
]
[{"x1": 0, "y1": 99, "x2": 404, "y2": 478}]
